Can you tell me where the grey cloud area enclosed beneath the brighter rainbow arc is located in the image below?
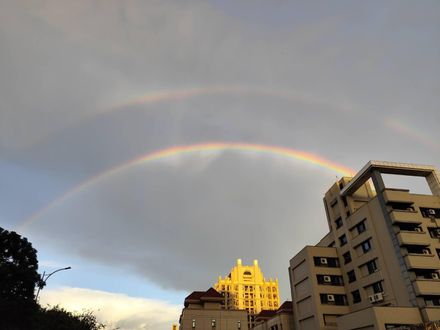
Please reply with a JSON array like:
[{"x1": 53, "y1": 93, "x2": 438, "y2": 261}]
[{"x1": 29, "y1": 152, "x2": 334, "y2": 298}]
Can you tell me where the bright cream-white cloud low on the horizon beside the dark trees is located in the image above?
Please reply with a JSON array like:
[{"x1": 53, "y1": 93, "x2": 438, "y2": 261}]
[{"x1": 40, "y1": 287, "x2": 182, "y2": 330}]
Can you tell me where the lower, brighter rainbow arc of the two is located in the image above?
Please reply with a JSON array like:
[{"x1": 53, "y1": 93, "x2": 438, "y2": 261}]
[{"x1": 16, "y1": 142, "x2": 354, "y2": 232}]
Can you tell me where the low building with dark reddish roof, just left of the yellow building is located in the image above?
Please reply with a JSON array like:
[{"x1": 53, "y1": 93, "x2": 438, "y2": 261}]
[{"x1": 179, "y1": 288, "x2": 248, "y2": 330}]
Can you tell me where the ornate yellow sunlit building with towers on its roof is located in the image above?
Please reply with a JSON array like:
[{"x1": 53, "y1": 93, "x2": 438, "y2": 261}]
[{"x1": 214, "y1": 259, "x2": 280, "y2": 329}]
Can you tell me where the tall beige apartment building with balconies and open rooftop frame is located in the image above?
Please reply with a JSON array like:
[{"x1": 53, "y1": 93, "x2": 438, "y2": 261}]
[{"x1": 289, "y1": 161, "x2": 440, "y2": 330}]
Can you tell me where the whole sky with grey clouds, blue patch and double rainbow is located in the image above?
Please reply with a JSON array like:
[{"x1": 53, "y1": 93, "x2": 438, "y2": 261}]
[{"x1": 0, "y1": 0, "x2": 440, "y2": 330}]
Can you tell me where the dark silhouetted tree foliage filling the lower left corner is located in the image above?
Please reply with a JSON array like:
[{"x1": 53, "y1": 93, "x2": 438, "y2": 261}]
[{"x1": 0, "y1": 227, "x2": 105, "y2": 330}]
